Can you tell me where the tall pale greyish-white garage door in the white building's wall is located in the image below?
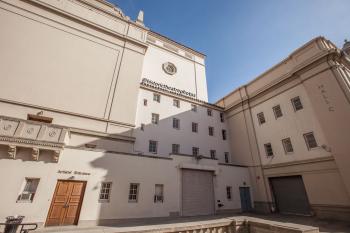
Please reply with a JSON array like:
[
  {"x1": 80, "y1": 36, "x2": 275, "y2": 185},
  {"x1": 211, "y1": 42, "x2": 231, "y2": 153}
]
[{"x1": 182, "y1": 169, "x2": 215, "y2": 216}]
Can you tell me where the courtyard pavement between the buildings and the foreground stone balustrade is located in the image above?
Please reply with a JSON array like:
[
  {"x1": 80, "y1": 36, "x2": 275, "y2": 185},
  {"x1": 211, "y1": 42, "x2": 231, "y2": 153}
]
[{"x1": 35, "y1": 214, "x2": 350, "y2": 233}]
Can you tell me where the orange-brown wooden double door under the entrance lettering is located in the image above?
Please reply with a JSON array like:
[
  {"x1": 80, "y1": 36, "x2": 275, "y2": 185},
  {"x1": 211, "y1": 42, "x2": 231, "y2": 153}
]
[{"x1": 46, "y1": 180, "x2": 86, "y2": 226}]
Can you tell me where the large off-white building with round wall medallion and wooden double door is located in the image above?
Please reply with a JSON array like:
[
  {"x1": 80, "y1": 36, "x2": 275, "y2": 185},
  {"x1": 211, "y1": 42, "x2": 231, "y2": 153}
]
[{"x1": 0, "y1": 0, "x2": 252, "y2": 226}]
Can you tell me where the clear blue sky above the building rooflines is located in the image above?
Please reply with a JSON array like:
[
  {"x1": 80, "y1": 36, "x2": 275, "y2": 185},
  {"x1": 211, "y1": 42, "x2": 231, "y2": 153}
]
[{"x1": 109, "y1": 0, "x2": 350, "y2": 102}]
